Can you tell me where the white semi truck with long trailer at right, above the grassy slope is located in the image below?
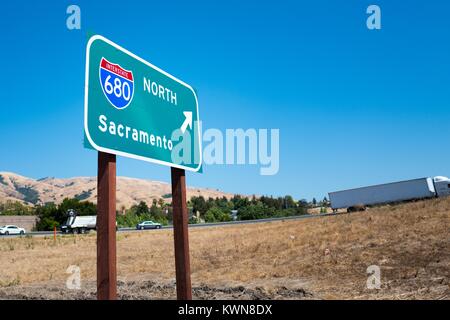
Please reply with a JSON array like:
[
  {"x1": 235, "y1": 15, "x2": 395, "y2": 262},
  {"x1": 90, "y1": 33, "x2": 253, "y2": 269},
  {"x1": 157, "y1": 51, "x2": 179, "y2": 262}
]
[{"x1": 328, "y1": 176, "x2": 450, "y2": 212}]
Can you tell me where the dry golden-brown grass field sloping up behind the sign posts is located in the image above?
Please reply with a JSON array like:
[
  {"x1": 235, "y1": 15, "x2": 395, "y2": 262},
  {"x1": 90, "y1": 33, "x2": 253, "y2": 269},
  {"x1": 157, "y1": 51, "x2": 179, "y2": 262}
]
[{"x1": 0, "y1": 198, "x2": 450, "y2": 299}]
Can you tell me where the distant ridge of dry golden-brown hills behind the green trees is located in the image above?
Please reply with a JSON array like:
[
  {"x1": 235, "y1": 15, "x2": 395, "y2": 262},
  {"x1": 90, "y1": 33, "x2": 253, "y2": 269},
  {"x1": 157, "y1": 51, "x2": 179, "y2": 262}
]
[{"x1": 0, "y1": 172, "x2": 237, "y2": 209}]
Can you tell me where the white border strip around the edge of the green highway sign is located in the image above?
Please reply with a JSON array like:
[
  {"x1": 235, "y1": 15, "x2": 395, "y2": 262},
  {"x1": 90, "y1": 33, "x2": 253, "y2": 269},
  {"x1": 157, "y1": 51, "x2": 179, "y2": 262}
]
[{"x1": 84, "y1": 35, "x2": 203, "y2": 172}]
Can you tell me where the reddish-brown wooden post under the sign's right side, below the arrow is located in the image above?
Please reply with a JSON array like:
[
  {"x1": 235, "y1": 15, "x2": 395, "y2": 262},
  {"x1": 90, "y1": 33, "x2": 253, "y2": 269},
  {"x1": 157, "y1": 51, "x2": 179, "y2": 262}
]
[{"x1": 171, "y1": 168, "x2": 192, "y2": 300}]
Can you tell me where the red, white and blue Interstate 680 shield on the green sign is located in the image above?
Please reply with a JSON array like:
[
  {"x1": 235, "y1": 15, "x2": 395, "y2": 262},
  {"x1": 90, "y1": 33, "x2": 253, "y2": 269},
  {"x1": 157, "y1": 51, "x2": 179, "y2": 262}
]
[{"x1": 99, "y1": 58, "x2": 134, "y2": 109}]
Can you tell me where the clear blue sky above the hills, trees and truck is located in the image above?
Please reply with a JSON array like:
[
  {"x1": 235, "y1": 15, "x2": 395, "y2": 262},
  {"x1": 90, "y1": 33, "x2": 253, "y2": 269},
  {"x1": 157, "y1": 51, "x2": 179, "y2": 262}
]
[{"x1": 0, "y1": 0, "x2": 450, "y2": 199}]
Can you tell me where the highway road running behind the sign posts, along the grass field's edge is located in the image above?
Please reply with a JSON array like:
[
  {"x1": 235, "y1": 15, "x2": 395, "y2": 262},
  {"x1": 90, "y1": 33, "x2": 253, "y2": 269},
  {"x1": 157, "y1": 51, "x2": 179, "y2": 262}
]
[{"x1": 0, "y1": 213, "x2": 336, "y2": 239}]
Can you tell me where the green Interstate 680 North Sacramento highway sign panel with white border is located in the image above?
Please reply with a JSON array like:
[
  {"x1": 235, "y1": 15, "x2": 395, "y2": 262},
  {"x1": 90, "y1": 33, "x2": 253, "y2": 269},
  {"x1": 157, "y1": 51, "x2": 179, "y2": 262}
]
[{"x1": 84, "y1": 35, "x2": 202, "y2": 171}]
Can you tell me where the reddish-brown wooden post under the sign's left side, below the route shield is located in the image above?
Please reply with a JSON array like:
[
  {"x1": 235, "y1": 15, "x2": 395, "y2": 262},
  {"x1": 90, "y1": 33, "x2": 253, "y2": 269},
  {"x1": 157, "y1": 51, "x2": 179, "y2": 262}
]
[{"x1": 97, "y1": 152, "x2": 117, "y2": 300}]
